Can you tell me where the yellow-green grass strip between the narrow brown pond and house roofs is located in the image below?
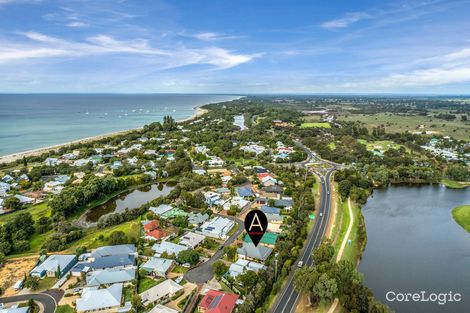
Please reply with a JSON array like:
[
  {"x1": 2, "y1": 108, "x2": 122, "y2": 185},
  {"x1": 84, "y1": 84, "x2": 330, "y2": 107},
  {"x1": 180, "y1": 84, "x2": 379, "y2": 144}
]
[{"x1": 66, "y1": 220, "x2": 140, "y2": 253}]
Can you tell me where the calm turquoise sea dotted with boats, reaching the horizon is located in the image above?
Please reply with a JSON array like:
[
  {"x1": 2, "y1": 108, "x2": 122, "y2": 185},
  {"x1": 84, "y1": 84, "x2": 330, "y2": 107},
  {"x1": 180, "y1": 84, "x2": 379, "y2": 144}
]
[{"x1": 0, "y1": 94, "x2": 239, "y2": 155}]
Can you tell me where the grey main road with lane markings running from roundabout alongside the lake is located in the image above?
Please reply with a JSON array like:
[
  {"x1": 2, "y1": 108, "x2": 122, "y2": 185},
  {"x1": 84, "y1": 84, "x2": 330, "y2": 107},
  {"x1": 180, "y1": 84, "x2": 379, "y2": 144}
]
[{"x1": 271, "y1": 144, "x2": 337, "y2": 313}]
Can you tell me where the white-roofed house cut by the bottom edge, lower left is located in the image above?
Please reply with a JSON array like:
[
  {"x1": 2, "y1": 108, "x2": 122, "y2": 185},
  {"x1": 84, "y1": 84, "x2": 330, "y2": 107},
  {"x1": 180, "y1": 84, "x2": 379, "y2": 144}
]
[{"x1": 76, "y1": 284, "x2": 122, "y2": 313}]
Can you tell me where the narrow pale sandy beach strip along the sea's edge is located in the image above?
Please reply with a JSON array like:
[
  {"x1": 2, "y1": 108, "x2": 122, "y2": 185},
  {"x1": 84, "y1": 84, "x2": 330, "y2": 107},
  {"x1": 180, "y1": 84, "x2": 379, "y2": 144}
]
[{"x1": 0, "y1": 106, "x2": 209, "y2": 164}]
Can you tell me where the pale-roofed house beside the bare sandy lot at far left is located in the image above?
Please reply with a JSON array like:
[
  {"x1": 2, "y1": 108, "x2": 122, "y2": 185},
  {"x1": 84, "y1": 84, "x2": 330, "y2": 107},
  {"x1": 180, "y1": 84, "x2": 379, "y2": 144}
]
[{"x1": 29, "y1": 254, "x2": 77, "y2": 278}]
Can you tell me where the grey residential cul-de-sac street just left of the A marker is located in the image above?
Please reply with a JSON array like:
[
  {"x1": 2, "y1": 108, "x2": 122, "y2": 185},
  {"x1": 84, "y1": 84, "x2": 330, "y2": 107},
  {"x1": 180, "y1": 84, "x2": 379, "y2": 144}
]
[{"x1": 184, "y1": 216, "x2": 244, "y2": 284}]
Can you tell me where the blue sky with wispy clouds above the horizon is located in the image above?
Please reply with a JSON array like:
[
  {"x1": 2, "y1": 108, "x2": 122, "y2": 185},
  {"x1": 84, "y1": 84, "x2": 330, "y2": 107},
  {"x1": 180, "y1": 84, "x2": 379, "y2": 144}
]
[{"x1": 0, "y1": 0, "x2": 470, "y2": 94}]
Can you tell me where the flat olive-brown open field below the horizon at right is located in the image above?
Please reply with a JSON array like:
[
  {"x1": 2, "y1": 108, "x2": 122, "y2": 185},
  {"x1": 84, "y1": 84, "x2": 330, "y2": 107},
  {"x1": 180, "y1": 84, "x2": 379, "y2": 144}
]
[{"x1": 338, "y1": 113, "x2": 470, "y2": 140}]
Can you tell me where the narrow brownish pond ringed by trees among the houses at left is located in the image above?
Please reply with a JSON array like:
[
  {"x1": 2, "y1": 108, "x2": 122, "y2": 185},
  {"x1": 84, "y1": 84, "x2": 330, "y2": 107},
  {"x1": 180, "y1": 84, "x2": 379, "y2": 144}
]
[{"x1": 85, "y1": 183, "x2": 175, "y2": 223}]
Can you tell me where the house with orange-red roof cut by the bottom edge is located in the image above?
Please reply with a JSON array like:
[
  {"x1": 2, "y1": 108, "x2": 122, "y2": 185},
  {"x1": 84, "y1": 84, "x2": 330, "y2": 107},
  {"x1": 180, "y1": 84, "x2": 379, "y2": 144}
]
[{"x1": 198, "y1": 289, "x2": 238, "y2": 313}]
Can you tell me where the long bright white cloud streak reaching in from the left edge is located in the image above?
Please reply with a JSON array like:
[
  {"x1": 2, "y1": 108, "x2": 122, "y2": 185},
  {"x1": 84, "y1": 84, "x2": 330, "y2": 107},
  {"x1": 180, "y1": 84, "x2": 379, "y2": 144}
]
[{"x1": 0, "y1": 32, "x2": 261, "y2": 69}]
